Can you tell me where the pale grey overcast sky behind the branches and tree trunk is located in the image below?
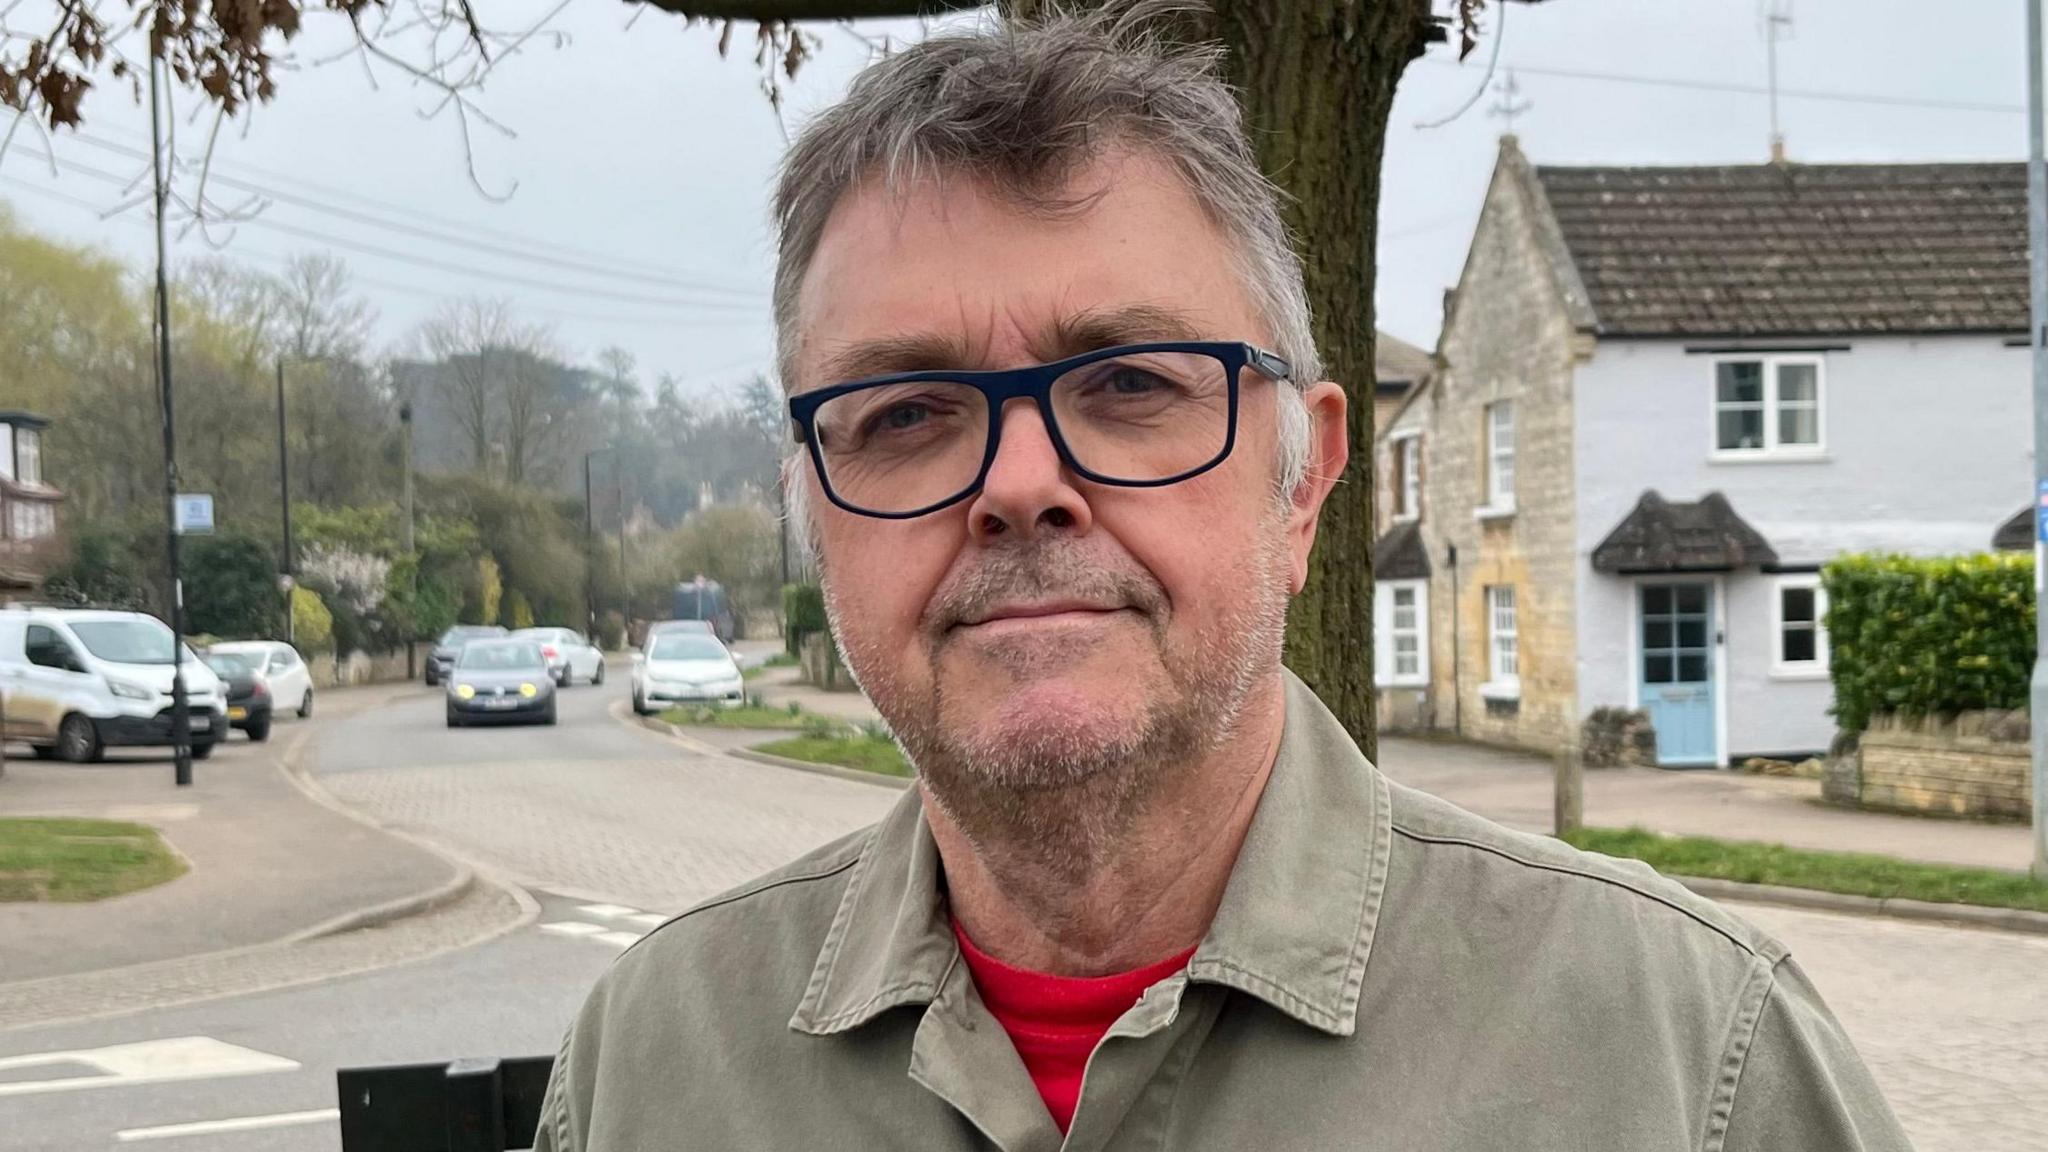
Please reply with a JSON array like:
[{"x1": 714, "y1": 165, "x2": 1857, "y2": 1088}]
[{"x1": 0, "y1": 0, "x2": 2025, "y2": 389}]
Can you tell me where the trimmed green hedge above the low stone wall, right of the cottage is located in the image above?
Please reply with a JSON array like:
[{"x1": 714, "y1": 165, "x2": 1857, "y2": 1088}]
[{"x1": 1821, "y1": 553, "x2": 2034, "y2": 732}]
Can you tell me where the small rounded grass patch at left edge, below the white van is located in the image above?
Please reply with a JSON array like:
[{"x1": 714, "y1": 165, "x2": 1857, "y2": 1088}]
[{"x1": 0, "y1": 820, "x2": 184, "y2": 904}]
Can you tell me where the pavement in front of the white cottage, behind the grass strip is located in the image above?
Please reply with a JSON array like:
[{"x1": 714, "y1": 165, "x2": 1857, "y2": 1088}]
[{"x1": 1378, "y1": 736, "x2": 2034, "y2": 871}]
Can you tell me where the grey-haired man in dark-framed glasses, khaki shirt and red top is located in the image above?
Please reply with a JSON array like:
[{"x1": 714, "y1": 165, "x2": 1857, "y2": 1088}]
[{"x1": 541, "y1": 6, "x2": 1907, "y2": 1152}]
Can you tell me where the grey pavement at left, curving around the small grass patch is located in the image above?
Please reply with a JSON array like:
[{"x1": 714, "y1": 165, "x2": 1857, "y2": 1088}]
[{"x1": 0, "y1": 685, "x2": 465, "y2": 982}]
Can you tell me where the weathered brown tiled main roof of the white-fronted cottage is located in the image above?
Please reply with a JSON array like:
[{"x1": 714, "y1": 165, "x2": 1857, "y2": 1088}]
[{"x1": 1534, "y1": 164, "x2": 2028, "y2": 336}]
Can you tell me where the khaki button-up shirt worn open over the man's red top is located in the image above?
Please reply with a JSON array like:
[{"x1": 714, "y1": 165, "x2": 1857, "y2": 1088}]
[{"x1": 537, "y1": 676, "x2": 1909, "y2": 1152}]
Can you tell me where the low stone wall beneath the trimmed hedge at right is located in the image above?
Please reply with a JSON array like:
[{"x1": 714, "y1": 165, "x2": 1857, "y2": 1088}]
[{"x1": 1855, "y1": 711, "x2": 2034, "y2": 820}]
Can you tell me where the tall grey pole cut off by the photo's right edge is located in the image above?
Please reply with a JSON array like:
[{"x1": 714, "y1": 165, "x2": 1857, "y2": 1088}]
[{"x1": 2028, "y1": 0, "x2": 2048, "y2": 879}]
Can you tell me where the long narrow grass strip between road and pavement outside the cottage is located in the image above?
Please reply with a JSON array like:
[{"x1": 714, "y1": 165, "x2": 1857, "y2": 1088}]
[{"x1": 1565, "y1": 828, "x2": 2048, "y2": 912}]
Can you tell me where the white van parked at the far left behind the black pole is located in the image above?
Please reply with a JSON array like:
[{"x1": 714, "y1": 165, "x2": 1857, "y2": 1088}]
[{"x1": 0, "y1": 609, "x2": 227, "y2": 763}]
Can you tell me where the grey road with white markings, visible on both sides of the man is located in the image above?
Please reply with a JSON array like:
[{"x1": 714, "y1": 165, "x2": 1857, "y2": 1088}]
[{"x1": 0, "y1": 676, "x2": 2048, "y2": 1152}]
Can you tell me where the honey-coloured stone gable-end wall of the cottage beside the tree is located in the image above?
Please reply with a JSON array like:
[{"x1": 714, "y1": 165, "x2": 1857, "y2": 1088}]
[{"x1": 1411, "y1": 143, "x2": 1589, "y2": 750}]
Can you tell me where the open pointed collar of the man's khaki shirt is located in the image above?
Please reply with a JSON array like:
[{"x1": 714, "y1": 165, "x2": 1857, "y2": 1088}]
[{"x1": 791, "y1": 672, "x2": 1393, "y2": 1035}]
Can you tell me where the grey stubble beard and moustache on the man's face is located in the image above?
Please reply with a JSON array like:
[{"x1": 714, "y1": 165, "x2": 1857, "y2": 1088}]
[{"x1": 823, "y1": 512, "x2": 1288, "y2": 883}]
